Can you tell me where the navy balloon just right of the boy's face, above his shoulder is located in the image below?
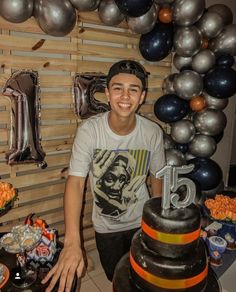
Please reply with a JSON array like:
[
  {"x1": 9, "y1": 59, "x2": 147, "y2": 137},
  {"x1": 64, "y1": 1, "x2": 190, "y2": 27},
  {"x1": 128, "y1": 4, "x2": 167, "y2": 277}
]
[{"x1": 154, "y1": 94, "x2": 189, "y2": 123}]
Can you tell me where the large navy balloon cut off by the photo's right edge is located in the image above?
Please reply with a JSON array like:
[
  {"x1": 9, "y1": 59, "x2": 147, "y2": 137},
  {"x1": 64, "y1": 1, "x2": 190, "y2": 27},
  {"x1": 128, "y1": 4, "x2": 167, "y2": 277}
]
[{"x1": 203, "y1": 66, "x2": 236, "y2": 98}]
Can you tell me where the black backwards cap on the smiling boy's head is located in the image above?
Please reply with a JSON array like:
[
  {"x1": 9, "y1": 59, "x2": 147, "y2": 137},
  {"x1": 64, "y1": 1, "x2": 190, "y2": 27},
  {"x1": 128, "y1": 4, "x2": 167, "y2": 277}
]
[{"x1": 107, "y1": 60, "x2": 149, "y2": 90}]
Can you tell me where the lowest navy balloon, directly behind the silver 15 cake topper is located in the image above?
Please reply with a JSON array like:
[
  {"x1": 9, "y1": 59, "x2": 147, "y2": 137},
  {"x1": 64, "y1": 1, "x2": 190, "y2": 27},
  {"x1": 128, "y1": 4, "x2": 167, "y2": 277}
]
[{"x1": 186, "y1": 157, "x2": 223, "y2": 191}]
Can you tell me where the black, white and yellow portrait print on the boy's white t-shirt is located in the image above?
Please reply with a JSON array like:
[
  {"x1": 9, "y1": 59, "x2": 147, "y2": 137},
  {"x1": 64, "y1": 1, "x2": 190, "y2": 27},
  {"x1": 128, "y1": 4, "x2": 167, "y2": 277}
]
[{"x1": 93, "y1": 149, "x2": 150, "y2": 220}]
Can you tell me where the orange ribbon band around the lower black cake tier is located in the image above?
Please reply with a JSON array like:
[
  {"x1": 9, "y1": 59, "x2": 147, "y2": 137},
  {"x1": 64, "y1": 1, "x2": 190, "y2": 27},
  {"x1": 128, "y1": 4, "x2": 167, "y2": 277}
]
[{"x1": 130, "y1": 253, "x2": 208, "y2": 289}]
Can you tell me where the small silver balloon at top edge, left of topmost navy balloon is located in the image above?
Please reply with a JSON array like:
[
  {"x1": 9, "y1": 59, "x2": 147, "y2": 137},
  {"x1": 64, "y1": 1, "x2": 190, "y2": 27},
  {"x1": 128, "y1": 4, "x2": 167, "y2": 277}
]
[{"x1": 98, "y1": 0, "x2": 125, "y2": 25}]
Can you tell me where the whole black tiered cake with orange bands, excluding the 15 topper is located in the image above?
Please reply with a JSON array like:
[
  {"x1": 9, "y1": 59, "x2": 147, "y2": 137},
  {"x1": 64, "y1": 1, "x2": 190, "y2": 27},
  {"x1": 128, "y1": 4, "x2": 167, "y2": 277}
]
[{"x1": 113, "y1": 165, "x2": 219, "y2": 292}]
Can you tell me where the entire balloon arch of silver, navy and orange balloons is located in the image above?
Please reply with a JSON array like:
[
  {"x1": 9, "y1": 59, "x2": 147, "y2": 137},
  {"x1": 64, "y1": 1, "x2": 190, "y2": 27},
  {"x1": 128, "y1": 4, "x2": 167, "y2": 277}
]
[{"x1": 0, "y1": 0, "x2": 236, "y2": 193}]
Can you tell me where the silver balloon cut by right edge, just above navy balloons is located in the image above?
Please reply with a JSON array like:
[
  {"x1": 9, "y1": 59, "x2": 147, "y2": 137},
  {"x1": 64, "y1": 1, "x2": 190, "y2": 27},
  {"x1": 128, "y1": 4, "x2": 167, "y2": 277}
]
[{"x1": 209, "y1": 24, "x2": 236, "y2": 56}]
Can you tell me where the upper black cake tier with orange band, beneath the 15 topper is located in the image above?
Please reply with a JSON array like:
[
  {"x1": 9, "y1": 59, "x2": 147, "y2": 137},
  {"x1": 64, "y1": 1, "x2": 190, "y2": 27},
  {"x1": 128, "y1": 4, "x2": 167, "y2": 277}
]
[{"x1": 142, "y1": 198, "x2": 200, "y2": 258}]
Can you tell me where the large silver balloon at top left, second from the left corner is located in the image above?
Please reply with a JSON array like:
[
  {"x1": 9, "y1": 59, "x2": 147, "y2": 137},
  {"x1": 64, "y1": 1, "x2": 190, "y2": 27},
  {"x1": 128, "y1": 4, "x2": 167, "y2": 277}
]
[{"x1": 34, "y1": 0, "x2": 76, "y2": 36}]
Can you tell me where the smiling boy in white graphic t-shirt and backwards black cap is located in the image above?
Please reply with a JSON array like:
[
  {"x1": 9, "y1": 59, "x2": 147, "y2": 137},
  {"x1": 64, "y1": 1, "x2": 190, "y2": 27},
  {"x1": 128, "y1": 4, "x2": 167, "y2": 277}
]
[{"x1": 44, "y1": 60, "x2": 165, "y2": 292}]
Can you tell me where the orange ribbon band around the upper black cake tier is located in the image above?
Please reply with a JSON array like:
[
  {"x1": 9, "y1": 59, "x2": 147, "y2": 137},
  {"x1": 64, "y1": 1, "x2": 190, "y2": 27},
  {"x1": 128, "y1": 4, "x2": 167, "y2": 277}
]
[{"x1": 142, "y1": 220, "x2": 201, "y2": 245}]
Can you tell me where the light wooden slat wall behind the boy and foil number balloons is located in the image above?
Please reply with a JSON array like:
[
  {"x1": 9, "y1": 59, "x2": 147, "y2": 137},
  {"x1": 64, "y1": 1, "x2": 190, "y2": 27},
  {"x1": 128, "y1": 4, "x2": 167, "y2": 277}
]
[{"x1": 0, "y1": 12, "x2": 171, "y2": 249}]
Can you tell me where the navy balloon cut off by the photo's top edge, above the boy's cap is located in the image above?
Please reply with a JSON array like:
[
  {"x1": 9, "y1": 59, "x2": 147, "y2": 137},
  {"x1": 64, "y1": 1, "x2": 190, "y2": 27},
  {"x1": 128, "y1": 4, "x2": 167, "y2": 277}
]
[{"x1": 115, "y1": 0, "x2": 154, "y2": 17}]
